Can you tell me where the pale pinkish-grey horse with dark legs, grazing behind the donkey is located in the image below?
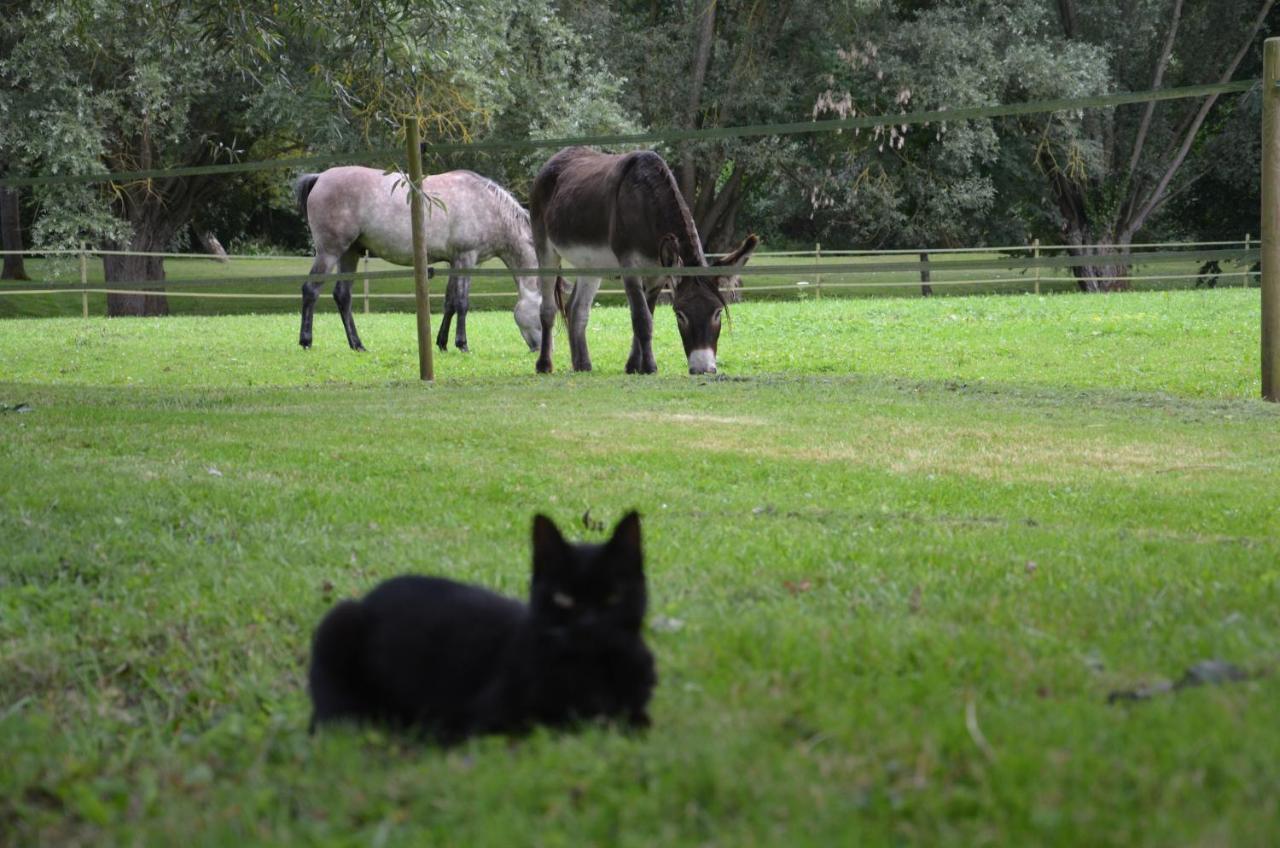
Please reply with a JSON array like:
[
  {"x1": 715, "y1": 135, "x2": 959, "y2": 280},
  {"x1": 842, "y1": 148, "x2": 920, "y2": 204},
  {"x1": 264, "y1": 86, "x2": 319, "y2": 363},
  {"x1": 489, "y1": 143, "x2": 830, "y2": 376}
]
[{"x1": 294, "y1": 167, "x2": 541, "y2": 351}]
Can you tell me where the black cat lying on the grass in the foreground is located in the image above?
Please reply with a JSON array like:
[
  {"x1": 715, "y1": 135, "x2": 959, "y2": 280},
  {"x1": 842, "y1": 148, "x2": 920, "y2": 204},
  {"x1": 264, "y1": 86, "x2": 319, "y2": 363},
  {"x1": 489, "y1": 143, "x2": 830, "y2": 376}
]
[{"x1": 310, "y1": 512, "x2": 657, "y2": 743}]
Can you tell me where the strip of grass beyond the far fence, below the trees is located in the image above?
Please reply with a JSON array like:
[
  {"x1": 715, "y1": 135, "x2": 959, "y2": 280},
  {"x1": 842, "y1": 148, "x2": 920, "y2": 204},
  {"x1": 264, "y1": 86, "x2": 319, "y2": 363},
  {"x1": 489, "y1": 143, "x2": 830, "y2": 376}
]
[{"x1": 0, "y1": 252, "x2": 1257, "y2": 318}]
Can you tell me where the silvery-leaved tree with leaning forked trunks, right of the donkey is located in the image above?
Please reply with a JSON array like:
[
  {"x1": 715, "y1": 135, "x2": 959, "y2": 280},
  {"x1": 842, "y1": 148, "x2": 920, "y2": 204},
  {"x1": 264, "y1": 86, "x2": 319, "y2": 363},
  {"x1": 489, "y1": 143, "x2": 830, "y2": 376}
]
[{"x1": 818, "y1": 0, "x2": 1274, "y2": 291}]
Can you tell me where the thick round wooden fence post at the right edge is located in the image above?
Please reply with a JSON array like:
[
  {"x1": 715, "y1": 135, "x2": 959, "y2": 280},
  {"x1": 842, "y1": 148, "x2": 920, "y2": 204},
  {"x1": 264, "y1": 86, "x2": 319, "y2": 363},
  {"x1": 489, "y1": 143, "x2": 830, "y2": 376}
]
[{"x1": 1261, "y1": 38, "x2": 1280, "y2": 402}]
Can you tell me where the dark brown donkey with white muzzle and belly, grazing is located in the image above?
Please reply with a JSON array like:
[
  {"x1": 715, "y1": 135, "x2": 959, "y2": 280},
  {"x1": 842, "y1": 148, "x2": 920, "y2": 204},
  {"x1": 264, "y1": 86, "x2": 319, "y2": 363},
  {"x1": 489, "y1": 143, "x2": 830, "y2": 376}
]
[{"x1": 529, "y1": 147, "x2": 759, "y2": 374}]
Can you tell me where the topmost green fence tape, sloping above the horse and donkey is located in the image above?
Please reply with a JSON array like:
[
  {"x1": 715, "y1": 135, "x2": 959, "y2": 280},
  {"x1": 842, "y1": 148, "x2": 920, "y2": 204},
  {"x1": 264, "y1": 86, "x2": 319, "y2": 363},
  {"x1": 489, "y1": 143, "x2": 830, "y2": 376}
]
[{"x1": 0, "y1": 79, "x2": 1260, "y2": 188}]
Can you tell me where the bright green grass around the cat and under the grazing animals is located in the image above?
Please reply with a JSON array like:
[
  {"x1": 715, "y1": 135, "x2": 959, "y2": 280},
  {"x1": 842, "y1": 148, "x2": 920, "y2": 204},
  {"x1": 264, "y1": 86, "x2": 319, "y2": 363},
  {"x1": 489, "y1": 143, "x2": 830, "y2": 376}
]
[{"x1": 0, "y1": 289, "x2": 1280, "y2": 845}]
